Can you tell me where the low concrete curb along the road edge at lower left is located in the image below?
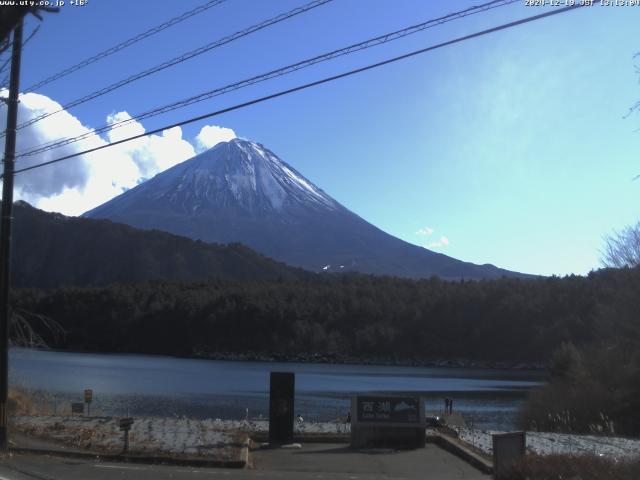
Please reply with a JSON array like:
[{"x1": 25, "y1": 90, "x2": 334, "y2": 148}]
[{"x1": 9, "y1": 444, "x2": 249, "y2": 468}]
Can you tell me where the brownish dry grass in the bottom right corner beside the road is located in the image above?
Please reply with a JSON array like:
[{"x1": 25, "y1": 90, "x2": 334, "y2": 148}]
[{"x1": 497, "y1": 455, "x2": 640, "y2": 480}]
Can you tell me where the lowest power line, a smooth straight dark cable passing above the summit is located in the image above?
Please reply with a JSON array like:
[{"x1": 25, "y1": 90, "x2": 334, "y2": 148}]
[{"x1": 14, "y1": 4, "x2": 586, "y2": 174}]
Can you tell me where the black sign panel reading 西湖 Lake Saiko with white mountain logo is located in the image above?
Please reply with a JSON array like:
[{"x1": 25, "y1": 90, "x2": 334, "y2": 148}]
[{"x1": 358, "y1": 397, "x2": 420, "y2": 423}]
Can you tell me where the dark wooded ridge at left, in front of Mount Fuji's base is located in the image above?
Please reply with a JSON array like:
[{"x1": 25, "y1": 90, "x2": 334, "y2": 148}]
[{"x1": 12, "y1": 202, "x2": 309, "y2": 288}]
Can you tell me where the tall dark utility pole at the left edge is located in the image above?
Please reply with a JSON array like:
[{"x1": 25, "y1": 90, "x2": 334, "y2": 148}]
[{"x1": 0, "y1": 20, "x2": 22, "y2": 451}]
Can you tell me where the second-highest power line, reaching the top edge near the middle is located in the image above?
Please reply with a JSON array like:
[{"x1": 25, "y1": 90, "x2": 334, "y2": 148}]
[{"x1": 10, "y1": 0, "x2": 333, "y2": 137}]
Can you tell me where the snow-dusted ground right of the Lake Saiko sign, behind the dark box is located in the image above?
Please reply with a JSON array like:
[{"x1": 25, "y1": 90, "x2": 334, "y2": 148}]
[{"x1": 456, "y1": 428, "x2": 640, "y2": 459}]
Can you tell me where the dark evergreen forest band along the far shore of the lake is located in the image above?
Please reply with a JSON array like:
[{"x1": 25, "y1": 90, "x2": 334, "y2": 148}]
[{"x1": 13, "y1": 268, "x2": 640, "y2": 364}]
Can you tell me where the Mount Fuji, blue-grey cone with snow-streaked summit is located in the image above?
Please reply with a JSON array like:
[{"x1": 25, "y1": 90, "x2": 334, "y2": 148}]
[{"x1": 84, "y1": 138, "x2": 525, "y2": 279}]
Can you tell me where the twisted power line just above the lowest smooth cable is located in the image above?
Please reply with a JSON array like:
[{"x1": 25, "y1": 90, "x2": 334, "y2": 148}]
[{"x1": 17, "y1": 0, "x2": 520, "y2": 158}]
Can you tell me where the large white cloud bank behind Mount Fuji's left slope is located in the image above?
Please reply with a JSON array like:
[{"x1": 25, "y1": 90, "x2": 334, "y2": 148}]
[{"x1": 0, "y1": 89, "x2": 235, "y2": 215}]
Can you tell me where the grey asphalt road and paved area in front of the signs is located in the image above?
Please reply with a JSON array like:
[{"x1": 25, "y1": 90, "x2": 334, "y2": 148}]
[{"x1": 0, "y1": 444, "x2": 490, "y2": 480}]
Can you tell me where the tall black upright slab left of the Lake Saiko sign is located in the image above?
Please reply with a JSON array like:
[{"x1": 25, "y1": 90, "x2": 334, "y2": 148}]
[{"x1": 269, "y1": 372, "x2": 295, "y2": 444}]
